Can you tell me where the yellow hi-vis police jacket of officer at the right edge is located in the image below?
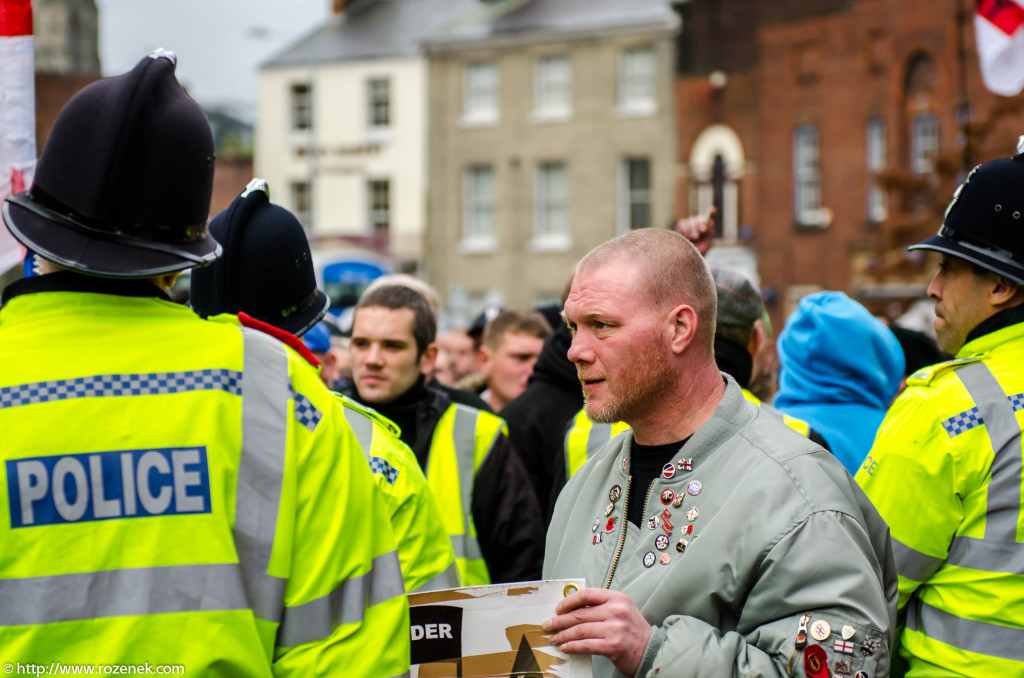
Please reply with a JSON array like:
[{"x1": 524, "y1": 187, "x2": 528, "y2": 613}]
[{"x1": 857, "y1": 323, "x2": 1024, "y2": 676}]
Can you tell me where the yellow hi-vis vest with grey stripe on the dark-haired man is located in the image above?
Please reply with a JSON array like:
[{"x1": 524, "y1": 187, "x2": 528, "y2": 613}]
[{"x1": 427, "y1": 402, "x2": 508, "y2": 586}]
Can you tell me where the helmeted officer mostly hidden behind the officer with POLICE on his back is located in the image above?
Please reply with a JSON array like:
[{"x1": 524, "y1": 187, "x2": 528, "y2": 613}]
[{"x1": 189, "y1": 179, "x2": 460, "y2": 592}]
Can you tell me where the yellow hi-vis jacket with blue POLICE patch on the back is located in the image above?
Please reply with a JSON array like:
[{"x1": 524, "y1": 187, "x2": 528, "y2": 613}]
[{"x1": 0, "y1": 272, "x2": 410, "y2": 676}]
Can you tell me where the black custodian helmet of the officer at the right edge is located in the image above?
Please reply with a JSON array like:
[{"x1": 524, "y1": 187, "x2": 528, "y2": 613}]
[{"x1": 908, "y1": 136, "x2": 1024, "y2": 286}]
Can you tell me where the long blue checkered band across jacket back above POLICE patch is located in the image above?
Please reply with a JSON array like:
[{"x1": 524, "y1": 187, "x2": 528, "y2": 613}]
[{"x1": 0, "y1": 370, "x2": 242, "y2": 410}]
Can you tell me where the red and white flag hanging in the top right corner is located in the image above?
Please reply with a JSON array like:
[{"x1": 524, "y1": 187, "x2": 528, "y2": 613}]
[{"x1": 974, "y1": 0, "x2": 1024, "y2": 96}]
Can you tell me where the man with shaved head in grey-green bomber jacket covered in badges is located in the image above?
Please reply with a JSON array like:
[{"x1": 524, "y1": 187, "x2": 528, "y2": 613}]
[{"x1": 543, "y1": 228, "x2": 896, "y2": 678}]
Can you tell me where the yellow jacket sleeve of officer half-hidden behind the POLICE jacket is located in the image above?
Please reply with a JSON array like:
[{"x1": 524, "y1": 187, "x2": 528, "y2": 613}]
[{"x1": 336, "y1": 393, "x2": 461, "y2": 593}]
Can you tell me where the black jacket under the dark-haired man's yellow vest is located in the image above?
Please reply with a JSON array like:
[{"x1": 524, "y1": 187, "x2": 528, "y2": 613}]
[{"x1": 346, "y1": 377, "x2": 546, "y2": 584}]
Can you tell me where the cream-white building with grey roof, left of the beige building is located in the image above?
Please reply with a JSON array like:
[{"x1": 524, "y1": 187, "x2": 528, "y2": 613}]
[{"x1": 255, "y1": 0, "x2": 476, "y2": 267}]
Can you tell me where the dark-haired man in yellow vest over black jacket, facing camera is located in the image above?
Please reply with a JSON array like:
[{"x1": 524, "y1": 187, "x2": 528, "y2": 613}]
[{"x1": 349, "y1": 285, "x2": 544, "y2": 586}]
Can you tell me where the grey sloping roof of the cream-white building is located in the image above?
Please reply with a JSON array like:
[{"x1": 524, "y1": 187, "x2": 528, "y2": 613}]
[{"x1": 261, "y1": 0, "x2": 481, "y2": 68}]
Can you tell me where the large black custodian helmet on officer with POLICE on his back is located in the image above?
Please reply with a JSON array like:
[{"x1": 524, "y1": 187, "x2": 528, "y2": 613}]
[{"x1": 2, "y1": 50, "x2": 220, "y2": 278}]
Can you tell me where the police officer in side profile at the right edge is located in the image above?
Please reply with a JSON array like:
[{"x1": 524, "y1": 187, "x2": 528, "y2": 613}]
[{"x1": 857, "y1": 137, "x2": 1024, "y2": 676}]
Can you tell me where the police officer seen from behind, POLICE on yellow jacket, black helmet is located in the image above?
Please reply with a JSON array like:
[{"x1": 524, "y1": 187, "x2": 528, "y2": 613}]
[{"x1": 0, "y1": 51, "x2": 410, "y2": 676}]
